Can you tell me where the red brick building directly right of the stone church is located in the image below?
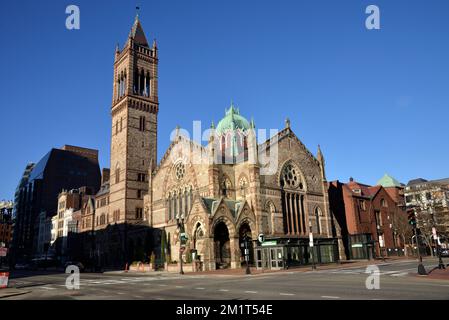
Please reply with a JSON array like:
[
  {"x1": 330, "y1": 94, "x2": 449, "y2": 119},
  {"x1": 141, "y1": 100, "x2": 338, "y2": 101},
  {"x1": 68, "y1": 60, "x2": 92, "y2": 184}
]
[{"x1": 329, "y1": 177, "x2": 406, "y2": 259}]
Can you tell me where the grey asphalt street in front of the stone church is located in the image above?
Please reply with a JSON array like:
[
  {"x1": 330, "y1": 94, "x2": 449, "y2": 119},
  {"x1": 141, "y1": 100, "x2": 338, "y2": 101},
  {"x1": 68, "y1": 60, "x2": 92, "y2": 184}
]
[{"x1": 1, "y1": 260, "x2": 449, "y2": 300}]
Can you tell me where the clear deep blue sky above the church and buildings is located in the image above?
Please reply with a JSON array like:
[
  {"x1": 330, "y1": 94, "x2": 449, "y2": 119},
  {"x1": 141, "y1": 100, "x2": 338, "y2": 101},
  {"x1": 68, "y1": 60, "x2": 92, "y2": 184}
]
[{"x1": 0, "y1": 0, "x2": 449, "y2": 199}]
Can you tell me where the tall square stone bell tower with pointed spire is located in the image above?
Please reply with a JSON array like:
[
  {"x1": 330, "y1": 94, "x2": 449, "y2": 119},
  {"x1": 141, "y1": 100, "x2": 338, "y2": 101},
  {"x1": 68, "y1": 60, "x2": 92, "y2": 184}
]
[{"x1": 109, "y1": 15, "x2": 159, "y2": 223}]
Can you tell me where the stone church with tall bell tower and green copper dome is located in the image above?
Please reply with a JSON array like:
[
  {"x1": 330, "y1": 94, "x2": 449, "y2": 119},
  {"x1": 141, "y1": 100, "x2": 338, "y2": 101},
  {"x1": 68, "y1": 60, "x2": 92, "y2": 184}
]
[{"x1": 87, "y1": 16, "x2": 339, "y2": 270}]
